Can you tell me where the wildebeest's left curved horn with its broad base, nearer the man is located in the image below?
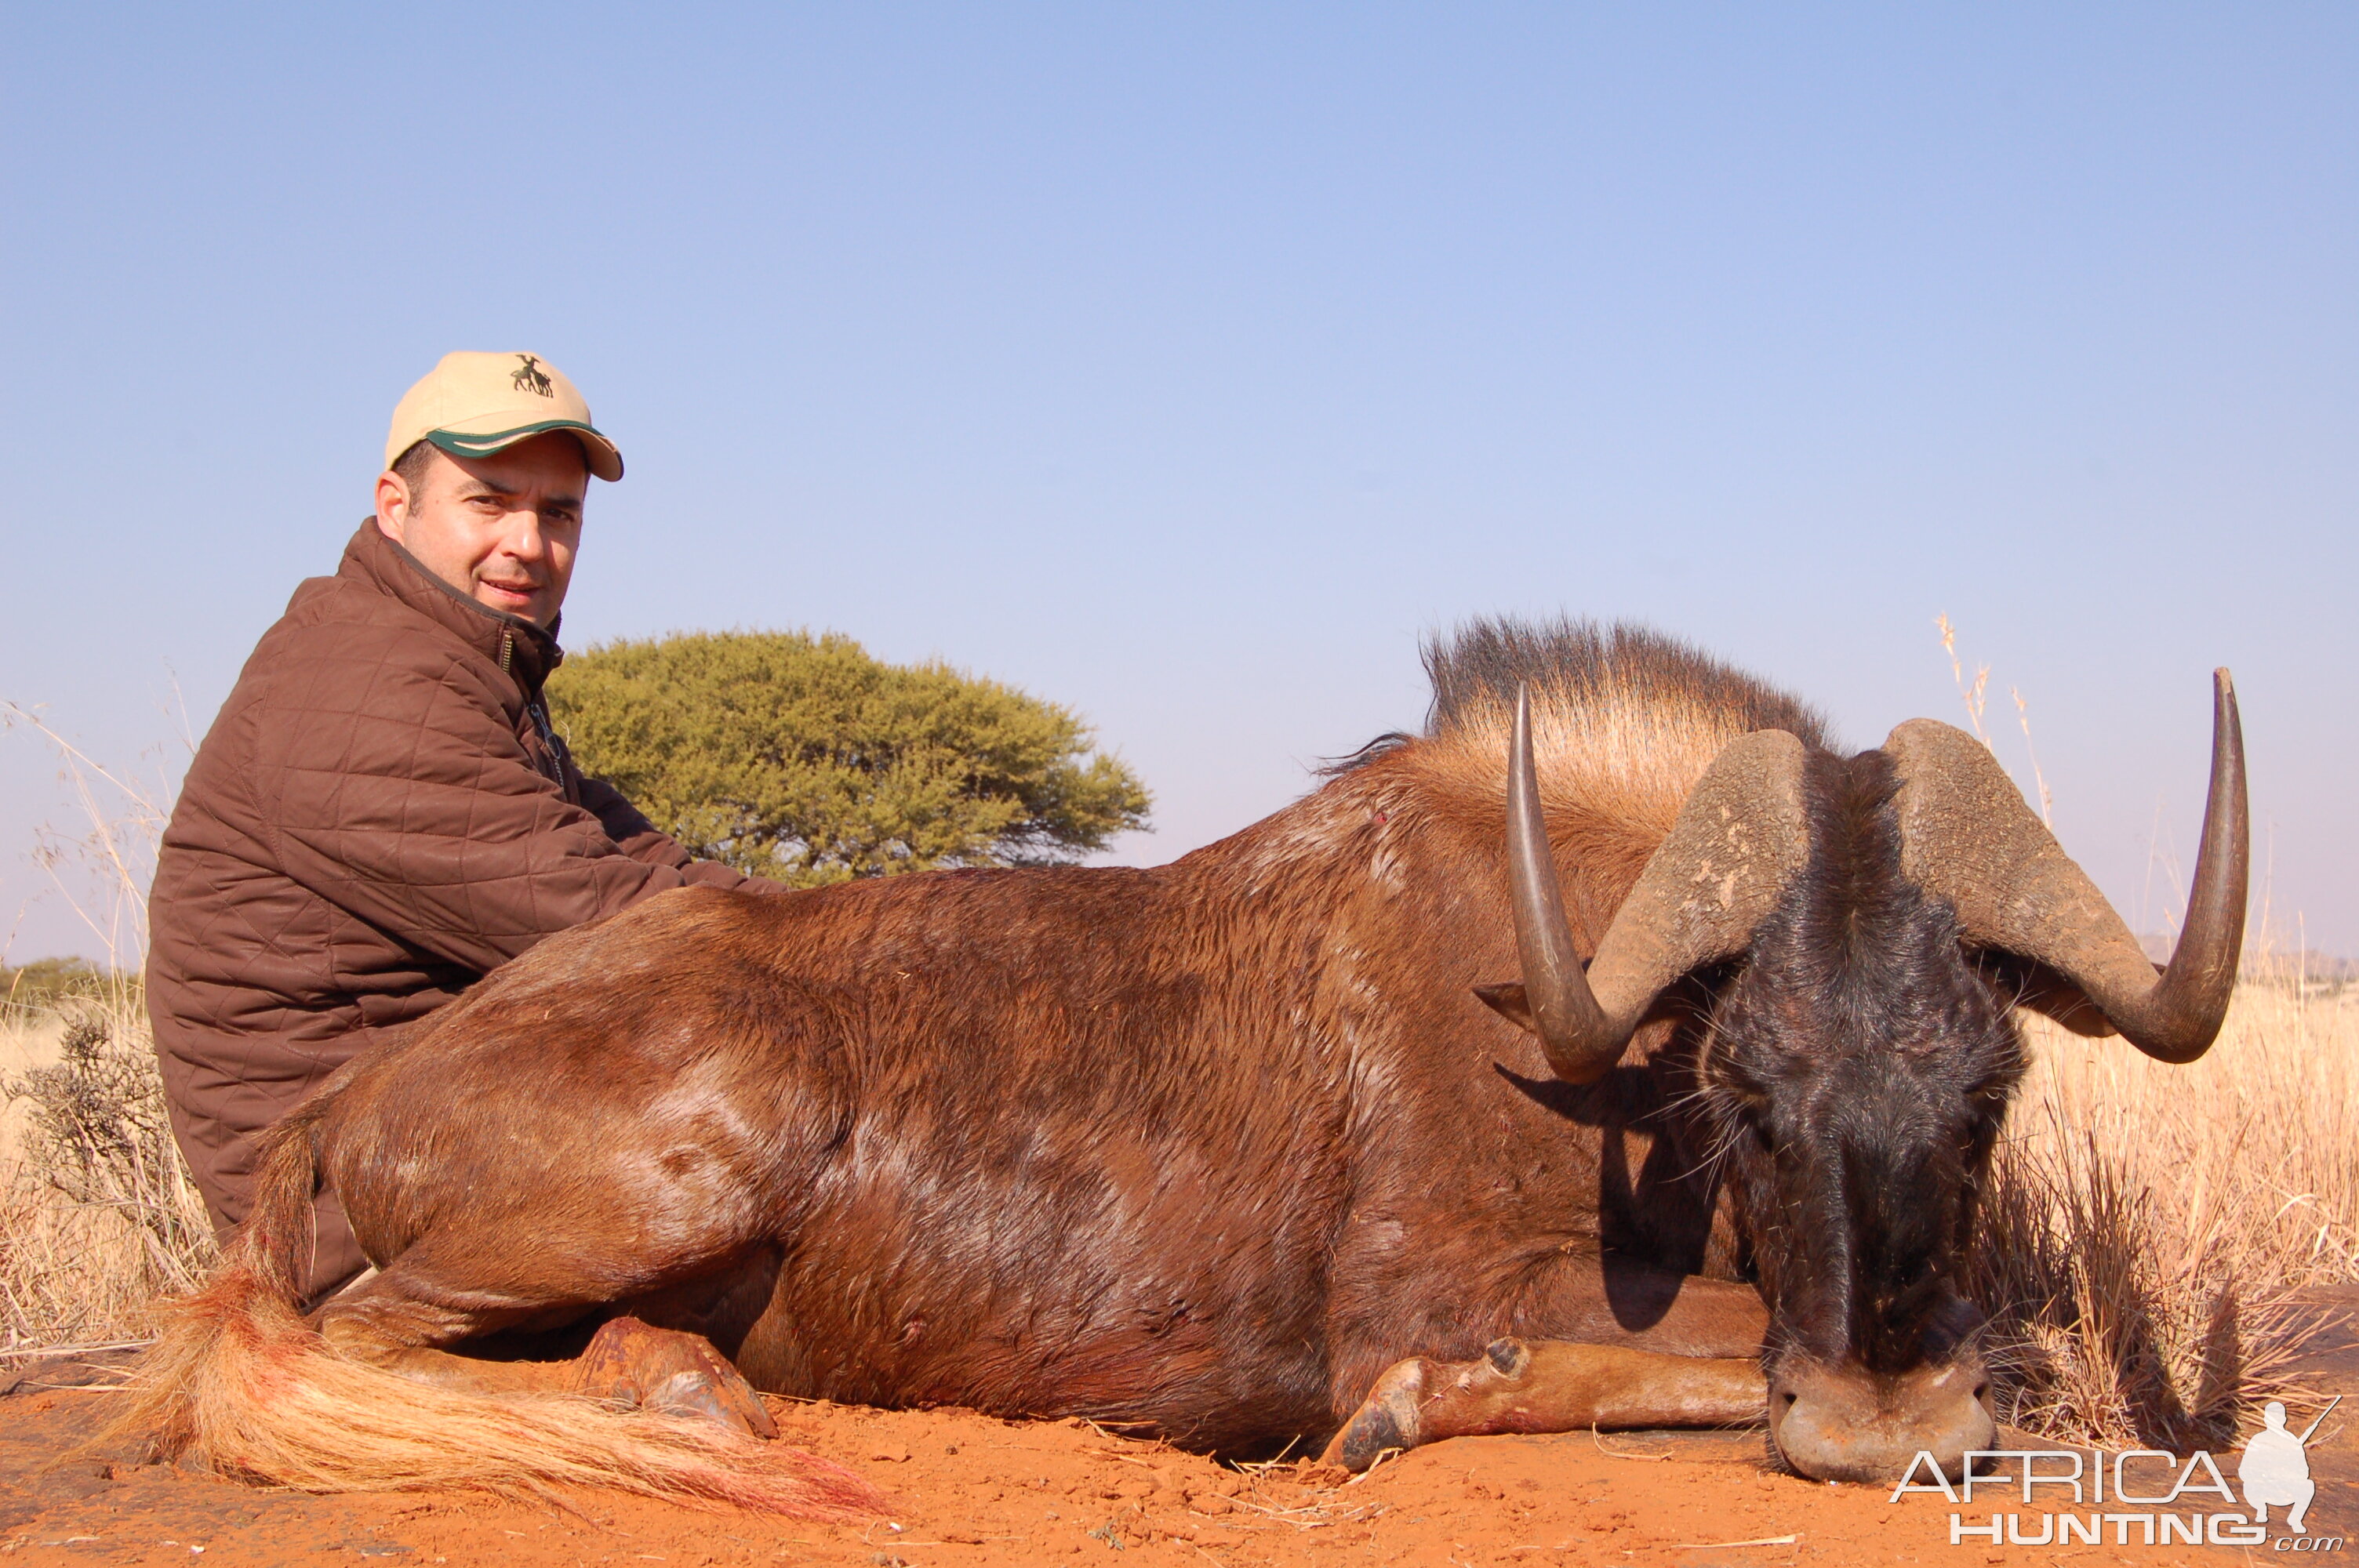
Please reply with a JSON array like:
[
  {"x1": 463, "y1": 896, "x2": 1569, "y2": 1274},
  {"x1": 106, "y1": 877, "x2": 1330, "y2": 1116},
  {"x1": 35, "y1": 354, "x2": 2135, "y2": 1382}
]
[{"x1": 1474, "y1": 688, "x2": 1809, "y2": 1084}]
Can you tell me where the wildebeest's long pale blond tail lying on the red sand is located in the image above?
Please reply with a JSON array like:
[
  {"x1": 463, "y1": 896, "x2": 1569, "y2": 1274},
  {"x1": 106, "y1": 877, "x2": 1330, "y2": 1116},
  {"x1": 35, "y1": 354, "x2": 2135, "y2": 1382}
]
[{"x1": 92, "y1": 1099, "x2": 882, "y2": 1519}]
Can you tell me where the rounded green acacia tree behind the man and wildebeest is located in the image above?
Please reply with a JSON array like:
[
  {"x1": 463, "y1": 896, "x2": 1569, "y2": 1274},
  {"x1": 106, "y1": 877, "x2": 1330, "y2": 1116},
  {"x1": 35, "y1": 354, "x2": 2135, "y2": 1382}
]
[{"x1": 547, "y1": 632, "x2": 1149, "y2": 887}]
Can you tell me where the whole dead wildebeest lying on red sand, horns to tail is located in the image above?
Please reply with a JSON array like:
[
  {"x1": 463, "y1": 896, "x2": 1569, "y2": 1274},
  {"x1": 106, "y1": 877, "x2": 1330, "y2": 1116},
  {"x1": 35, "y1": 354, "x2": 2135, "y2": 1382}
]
[{"x1": 118, "y1": 622, "x2": 2246, "y2": 1512}]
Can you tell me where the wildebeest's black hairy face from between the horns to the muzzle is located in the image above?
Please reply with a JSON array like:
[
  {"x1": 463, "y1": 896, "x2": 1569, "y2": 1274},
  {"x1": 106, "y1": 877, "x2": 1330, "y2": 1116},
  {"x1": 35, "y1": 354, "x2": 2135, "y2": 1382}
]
[{"x1": 1701, "y1": 752, "x2": 2024, "y2": 1374}]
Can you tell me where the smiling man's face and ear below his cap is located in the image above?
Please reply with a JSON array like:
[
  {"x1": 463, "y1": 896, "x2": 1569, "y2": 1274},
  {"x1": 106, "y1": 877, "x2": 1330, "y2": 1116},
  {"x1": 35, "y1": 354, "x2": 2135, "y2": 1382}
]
[{"x1": 377, "y1": 431, "x2": 590, "y2": 627}]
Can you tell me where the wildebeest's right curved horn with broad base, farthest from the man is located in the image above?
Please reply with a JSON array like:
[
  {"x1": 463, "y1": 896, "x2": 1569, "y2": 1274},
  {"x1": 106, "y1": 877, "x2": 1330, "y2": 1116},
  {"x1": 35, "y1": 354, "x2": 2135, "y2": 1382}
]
[{"x1": 1885, "y1": 670, "x2": 2251, "y2": 1061}]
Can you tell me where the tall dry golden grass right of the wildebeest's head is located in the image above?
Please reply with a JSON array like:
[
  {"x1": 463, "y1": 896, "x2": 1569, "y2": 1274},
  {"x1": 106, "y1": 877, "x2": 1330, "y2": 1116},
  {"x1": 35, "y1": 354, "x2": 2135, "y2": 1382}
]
[{"x1": 1970, "y1": 960, "x2": 2359, "y2": 1450}]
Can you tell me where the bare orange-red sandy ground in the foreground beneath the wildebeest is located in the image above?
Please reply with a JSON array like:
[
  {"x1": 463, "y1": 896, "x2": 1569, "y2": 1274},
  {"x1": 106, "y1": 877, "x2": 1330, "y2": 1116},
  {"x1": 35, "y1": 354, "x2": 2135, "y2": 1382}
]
[{"x1": 0, "y1": 1367, "x2": 2359, "y2": 1568}]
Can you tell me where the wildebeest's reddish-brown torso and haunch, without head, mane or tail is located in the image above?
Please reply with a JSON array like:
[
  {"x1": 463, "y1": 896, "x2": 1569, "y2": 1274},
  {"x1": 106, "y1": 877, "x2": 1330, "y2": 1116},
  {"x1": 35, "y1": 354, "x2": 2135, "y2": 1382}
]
[{"x1": 321, "y1": 761, "x2": 1710, "y2": 1453}]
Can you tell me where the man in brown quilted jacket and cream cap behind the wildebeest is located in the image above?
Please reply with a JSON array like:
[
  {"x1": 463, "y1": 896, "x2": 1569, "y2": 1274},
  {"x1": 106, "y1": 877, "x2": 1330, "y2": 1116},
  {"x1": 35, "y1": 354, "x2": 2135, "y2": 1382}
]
[{"x1": 149, "y1": 354, "x2": 776, "y2": 1294}]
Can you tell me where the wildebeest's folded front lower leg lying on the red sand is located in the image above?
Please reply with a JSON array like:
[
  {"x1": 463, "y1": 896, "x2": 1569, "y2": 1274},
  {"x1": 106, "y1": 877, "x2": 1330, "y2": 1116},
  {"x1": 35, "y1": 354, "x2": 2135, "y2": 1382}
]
[{"x1": 1323, "y1": 1339, "x2": 1765, "y2": 1472}]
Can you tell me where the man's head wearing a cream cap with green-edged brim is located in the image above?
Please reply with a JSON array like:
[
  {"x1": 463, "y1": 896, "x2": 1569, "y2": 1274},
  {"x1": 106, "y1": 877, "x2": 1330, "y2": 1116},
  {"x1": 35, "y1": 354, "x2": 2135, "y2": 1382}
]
[{"x1": 377, "y1": 354, "x2": 623, "y2": 627}]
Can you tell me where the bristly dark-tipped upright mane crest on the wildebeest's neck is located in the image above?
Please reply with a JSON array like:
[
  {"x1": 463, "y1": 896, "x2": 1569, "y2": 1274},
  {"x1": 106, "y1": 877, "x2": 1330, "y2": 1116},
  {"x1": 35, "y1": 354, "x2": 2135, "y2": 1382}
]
[{"x1": 1425, "y1": 615, "x2": 1828, "y2": 747}]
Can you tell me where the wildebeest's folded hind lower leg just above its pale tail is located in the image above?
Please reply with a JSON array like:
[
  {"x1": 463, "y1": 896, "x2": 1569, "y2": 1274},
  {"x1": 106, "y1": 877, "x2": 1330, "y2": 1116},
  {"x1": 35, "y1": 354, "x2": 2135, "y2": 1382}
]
[{"x1": 318, "y1": 1259, "x2": 779, "y2": 1439}]
